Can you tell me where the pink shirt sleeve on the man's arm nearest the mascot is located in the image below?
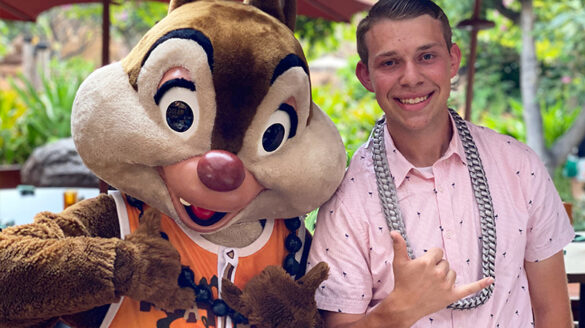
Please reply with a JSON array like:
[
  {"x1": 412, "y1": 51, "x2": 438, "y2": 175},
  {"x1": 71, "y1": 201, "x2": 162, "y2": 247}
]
[{"x1": 308, "y1": 191, "x2": 372, "y2": 313}]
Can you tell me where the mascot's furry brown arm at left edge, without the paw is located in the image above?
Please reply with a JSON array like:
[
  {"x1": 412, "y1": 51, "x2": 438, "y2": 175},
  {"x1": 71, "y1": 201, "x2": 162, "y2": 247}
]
[{"x1": 0, "y1": 195, "x2": 121, "y2": 327}]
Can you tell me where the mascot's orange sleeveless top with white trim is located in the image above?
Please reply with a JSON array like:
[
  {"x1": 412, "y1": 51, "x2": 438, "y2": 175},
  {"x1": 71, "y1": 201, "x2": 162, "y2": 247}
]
[{"x1": 101, "y1": 192, "x2": 305, "y2": 328}]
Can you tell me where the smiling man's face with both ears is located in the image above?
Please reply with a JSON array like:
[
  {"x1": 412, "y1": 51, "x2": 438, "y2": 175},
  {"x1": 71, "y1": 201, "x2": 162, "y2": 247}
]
[{"x1": 356, "y1": 15, "x2": 461, "y2": 135}]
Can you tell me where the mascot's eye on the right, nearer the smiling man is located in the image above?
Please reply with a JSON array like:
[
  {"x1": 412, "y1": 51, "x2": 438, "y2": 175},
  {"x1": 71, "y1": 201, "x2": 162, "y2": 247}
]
[{"x1": 259, "y1": 104, "x2": 298, "y2": 154}]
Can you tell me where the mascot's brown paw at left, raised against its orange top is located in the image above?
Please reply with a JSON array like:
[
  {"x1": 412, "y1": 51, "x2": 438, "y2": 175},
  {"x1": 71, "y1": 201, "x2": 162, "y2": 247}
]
[{"x1": 114, "y1": 209, "x2": 195, "y2": 311}]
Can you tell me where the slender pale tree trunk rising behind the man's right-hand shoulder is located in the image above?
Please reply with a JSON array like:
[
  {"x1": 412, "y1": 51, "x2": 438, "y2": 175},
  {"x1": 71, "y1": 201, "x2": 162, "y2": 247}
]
[{"x1": 520, "y1": 0, "x2": 554, "y2": 173}]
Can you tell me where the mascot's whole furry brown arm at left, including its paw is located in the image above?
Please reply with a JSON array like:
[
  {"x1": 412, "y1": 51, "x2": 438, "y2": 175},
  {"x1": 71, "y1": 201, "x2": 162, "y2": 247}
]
[{"x1": 0, "y1": 195, "x2": 195, "y2": 327}]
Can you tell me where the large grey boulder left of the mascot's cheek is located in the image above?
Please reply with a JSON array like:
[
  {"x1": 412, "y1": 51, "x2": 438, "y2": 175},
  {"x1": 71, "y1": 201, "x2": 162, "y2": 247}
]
[{"x1": 20, "y1": 138, "x2": 98, "y2": 188}]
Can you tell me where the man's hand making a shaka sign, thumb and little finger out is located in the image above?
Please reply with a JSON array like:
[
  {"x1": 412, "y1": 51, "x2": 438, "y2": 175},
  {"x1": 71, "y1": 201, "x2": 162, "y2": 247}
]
[{"x1": 389, "y1": 231, "x2": 494, "y2": 323}]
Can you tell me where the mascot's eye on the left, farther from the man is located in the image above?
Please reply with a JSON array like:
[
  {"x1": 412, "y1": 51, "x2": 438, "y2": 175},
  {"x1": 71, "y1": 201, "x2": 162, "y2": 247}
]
[{"x1": 154, "y1": 79, "x2": 199, "y2": 133}]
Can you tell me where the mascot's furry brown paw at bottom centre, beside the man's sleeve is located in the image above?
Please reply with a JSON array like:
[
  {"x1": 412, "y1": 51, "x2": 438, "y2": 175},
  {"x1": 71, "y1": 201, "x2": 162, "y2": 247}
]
[{"x1": 221, "y1": 262, "x2": 329, "y2": 328}]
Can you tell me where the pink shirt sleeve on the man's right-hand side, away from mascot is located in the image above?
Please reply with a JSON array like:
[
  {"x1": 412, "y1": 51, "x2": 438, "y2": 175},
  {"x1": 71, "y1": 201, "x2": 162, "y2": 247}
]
[{"x1": 525, "y1": 151, "x2": 575, "y2": 262}]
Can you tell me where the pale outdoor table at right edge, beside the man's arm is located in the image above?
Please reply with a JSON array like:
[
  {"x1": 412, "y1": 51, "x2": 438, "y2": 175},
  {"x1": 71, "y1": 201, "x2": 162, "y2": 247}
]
[{"x1": 565, "y1": 232, "x2": 585, "y2": 327}]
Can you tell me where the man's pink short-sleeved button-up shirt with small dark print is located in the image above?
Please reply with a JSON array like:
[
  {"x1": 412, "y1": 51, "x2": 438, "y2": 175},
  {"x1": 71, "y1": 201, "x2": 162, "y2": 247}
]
[{"x1": 309, "y1": 116, "x2": 574, "y2": 328}]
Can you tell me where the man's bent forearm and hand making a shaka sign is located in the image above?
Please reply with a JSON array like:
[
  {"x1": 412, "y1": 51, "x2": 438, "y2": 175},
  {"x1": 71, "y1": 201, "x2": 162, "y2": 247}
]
[{"x1": 322, "y1": 231, "x2": 490, "y2": 328}]
